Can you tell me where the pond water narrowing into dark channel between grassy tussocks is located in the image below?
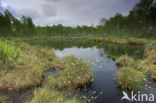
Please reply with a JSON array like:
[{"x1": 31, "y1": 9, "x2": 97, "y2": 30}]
[{"x1": 29, "y1": 40, "x2": 156, "y2": 103}]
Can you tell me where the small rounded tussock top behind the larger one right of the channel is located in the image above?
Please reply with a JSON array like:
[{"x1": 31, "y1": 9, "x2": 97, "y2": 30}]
[{"x1": 115, "y1": 55, "x2": 135, "y2": 66}]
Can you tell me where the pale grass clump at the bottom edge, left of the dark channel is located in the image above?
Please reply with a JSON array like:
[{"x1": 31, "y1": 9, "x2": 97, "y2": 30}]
[{"x1": 27, "y1": 87, "x2": 78, "y2": 103}]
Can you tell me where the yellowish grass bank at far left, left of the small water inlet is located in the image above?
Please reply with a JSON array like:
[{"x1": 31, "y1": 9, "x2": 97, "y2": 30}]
[{"x1": 0, "y1": 43, "x2": 55, "y2": 91}]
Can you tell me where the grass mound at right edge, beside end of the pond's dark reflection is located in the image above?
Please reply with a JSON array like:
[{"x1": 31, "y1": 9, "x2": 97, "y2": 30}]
[{"x1": 144, "y1": 45, "x2": 156, "y2": 64}]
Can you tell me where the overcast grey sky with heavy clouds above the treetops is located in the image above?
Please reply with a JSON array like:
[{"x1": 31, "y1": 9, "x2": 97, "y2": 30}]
[{"x1": 0, "y1": 0, "x2": 139, "y2": 26}]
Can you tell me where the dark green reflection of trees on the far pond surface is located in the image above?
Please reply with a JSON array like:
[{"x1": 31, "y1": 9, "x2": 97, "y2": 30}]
[{"x1": 31, "y1": 40, "x2": 145, "y2": 59}]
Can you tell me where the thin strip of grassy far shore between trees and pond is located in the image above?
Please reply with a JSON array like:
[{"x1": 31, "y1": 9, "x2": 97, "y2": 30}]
[{"x1": 5, "y1": 34, "x2": 156, "y2": 45}]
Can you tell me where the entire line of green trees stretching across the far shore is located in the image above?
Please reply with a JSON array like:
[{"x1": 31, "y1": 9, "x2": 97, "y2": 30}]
[{"x1": 0, "y1": 0, "x2": 156, "y2": 36}]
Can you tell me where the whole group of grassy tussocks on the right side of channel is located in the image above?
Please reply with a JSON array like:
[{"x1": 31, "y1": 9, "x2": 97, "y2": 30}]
[{"x1": 116, "y1": 45, "x2": 156, "y2": 90}]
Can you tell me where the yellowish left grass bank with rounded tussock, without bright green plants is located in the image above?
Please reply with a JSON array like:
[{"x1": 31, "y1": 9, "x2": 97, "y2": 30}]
[{"x1": 0, "y1": 40, "x2": 92, "y2": 92}]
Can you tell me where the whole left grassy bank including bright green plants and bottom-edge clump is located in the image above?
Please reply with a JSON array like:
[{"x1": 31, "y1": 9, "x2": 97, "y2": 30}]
[{"x1": 0, "y1": 40, "x2": 92, "y2": 103}]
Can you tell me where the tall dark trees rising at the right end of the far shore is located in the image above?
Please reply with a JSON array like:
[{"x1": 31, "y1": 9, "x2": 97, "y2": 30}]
[{"x1": 101, "y1": 0, "x2": 156, "y2": 36}]
